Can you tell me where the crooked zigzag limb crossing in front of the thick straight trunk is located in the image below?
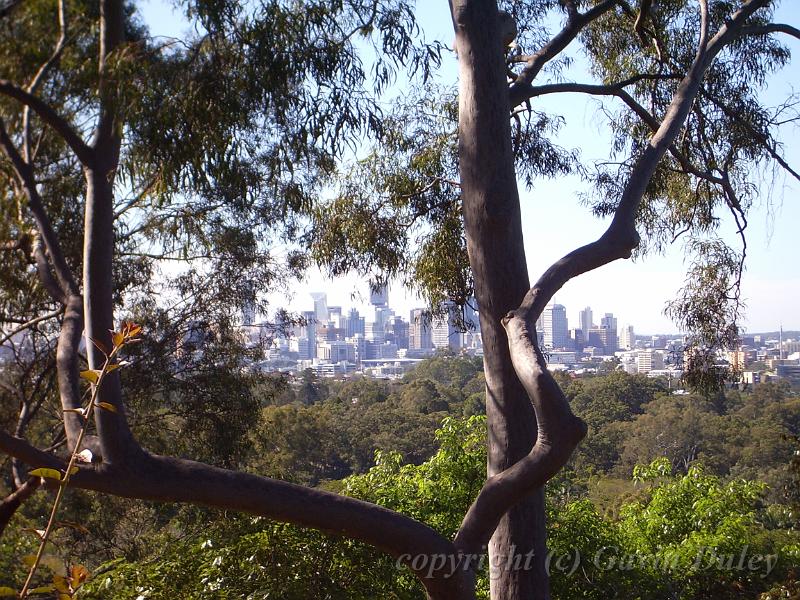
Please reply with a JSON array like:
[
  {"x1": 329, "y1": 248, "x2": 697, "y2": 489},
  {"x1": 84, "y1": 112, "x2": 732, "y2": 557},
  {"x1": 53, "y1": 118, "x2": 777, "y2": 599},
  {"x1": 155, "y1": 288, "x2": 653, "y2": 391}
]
[{"x1": 455, "y1": 0, "x2": 768, "y2": 552}]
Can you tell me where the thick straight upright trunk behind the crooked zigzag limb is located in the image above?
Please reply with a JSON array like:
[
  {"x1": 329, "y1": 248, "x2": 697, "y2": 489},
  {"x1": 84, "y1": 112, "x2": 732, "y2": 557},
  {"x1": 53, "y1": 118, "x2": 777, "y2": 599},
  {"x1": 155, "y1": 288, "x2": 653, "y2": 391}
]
[{"x1": 452, "y1": 0, "x2": 549, "y2": 600}]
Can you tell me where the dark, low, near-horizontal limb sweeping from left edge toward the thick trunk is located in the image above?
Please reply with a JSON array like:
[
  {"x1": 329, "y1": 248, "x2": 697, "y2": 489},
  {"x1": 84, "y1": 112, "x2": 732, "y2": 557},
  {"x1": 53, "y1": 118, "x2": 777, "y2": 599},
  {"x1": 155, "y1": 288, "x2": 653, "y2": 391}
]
[{"x1": 0, "y1": 432, "x2": 474, "y2": 600}]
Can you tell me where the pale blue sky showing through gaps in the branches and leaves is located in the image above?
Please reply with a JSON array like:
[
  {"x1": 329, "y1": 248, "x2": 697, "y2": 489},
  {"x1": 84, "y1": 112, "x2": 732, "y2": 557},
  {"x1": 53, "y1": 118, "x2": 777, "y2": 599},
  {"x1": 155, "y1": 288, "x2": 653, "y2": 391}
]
[{"x1": 143, "y1": 0, "x2": 800, "y2": 333}]
